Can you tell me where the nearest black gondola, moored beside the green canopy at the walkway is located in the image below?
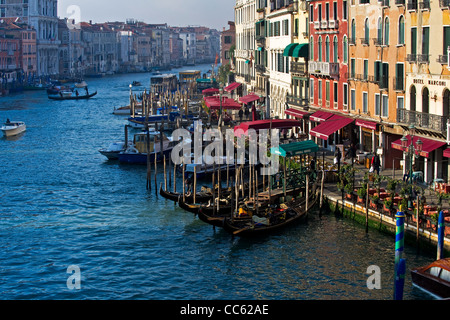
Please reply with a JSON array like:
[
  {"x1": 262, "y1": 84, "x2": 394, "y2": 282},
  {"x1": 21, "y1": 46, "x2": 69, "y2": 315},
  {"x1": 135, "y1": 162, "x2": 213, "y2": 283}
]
[{"x1": 223, "y1": 192, "x2": 316, "y2": 237}]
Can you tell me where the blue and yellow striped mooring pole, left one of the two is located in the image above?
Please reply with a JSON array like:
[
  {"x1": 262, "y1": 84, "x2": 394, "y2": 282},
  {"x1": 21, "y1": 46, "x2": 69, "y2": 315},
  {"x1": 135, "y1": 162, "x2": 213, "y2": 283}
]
[{"x1": 394, "y1": 211, "x2": 406, "y2": 300}]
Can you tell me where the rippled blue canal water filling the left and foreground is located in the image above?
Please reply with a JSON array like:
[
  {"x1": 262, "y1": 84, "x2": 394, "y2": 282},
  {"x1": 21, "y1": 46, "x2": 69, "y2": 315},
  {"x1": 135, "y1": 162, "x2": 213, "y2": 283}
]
[{"x1": 0, "y1": 65, "x2": 434, "y2": 300}]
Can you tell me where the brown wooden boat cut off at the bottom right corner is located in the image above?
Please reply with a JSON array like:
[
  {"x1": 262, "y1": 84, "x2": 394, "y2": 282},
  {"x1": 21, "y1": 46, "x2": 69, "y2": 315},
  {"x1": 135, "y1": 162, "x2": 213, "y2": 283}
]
[{"x1": 411, "y1": 258, "x2": 450, "y2": 299}]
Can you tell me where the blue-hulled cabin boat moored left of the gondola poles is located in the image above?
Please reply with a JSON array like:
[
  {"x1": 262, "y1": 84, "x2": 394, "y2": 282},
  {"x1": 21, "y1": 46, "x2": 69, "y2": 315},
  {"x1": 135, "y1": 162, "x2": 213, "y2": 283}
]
[{"x1": 118, "y1": 130, "x2": 173, "y2": 164}]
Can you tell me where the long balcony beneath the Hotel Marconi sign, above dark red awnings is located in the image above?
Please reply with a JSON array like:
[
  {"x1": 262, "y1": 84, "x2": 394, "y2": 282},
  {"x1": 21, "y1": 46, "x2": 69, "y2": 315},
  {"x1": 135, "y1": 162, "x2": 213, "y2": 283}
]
[{"x1": 397, "y1": 109, "x2": 449, "y2": 135}]
